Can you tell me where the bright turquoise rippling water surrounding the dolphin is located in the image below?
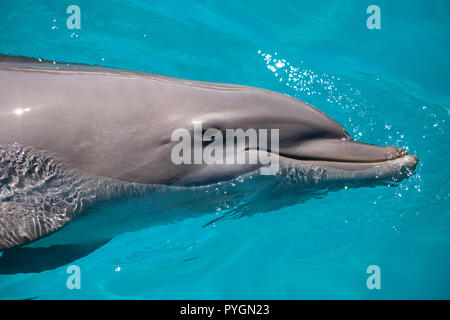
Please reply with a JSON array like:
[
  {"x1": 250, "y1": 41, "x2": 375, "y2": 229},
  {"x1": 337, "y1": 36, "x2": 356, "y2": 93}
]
[{"x1": 0, "y1": 0, "x2": 450, "y2": 299}]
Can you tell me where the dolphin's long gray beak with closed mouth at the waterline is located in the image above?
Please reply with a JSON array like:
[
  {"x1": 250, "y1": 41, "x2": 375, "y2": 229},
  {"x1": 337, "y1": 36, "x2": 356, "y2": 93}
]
[{"x1": 272, "y1": 139, "x2": 419, "y2": 181}]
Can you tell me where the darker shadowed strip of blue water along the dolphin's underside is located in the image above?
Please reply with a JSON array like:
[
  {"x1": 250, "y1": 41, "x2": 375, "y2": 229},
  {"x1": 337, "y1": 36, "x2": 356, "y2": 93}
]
[{"x1": 0, "y1": 168, "x2": 400, "y2": 274}]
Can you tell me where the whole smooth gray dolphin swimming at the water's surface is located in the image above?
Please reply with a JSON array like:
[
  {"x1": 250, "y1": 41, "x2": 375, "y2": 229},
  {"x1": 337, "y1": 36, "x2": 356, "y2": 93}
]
[{"x1": 0, "y1": 56, "x2": 418, "y2": 250}]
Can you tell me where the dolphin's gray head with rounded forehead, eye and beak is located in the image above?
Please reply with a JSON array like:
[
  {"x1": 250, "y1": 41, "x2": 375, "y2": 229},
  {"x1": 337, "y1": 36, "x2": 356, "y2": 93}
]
[{"x1": 169, "y1": 91, "x2": 418, "y2": 185}]
